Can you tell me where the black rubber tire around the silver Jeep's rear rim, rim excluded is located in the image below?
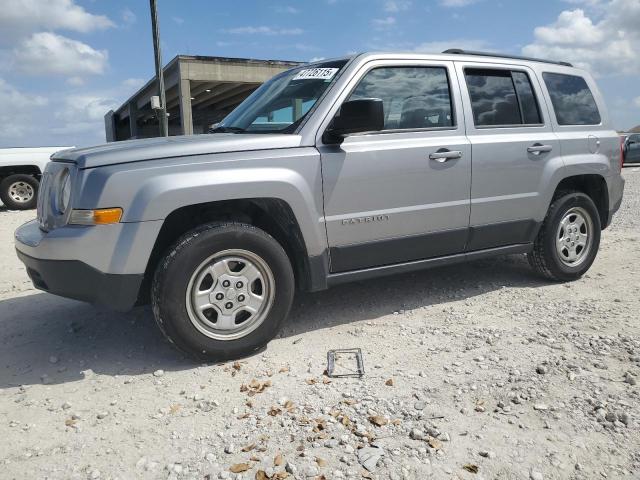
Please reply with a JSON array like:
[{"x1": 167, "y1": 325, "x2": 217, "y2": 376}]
[{"x1": 528, "y1": 191, "x2": 602, "y2": 282}]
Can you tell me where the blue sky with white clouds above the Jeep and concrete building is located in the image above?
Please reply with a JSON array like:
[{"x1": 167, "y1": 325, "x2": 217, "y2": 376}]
[{"x1": 0, "y1": 0, "x2": 640, "y2": 147}]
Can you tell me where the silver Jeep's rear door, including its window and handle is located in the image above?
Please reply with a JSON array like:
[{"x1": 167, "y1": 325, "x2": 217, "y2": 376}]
[{"x1": 456, "y1": 62, "x2": 562, "y2": 251}]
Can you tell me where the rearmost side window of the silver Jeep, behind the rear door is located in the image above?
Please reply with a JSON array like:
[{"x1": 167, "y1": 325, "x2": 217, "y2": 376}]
[{"x1": 542, "y1": 73, "x2": 600, "y2": 125}]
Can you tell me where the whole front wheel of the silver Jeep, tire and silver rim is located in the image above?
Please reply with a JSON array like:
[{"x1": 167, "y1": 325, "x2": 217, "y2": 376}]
[{"x1": 151, "y1": 223, "x2": 294, "y2": 361}]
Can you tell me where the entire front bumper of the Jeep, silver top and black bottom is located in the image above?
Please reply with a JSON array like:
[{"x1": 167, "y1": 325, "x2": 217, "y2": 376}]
[{"x1": 15, "y1": 221, "x2": 162, "y2": 311}]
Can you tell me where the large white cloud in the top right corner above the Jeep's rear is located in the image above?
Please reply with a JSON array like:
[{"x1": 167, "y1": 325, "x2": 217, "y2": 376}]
[{"x1": 522, "y1": 0, "x2": 640, "y2": 75}]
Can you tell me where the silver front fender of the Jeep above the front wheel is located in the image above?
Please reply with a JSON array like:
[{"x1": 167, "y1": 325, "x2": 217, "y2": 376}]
[{"x1": 74, "y1": 147, "x2": 326, "y2": 255}]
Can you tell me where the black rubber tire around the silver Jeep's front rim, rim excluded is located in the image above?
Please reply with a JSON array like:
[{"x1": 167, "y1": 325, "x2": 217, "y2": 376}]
[{"x1": 151, "y1": 223, "x2": 295, "y2": 361}]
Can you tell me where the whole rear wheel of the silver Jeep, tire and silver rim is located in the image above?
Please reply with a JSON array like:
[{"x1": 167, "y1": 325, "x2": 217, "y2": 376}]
[{"x1": 528, "y1": 192, "x2": 601, "y2": 281}]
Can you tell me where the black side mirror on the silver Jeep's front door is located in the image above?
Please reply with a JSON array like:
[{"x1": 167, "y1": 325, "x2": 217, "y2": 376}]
[{"x1": 324, "y1": 98, "x2": 384, "y2": 143}]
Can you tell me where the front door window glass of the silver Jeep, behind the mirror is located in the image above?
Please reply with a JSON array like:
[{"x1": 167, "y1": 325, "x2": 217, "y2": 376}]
[{"x1": 348, "y1": 67, "x2": 455, "y2": 130}]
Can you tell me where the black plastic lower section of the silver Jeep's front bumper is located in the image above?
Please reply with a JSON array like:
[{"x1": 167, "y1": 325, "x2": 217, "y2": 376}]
[{"x1": 17, "y1": 250, "x2": 144, "y2": 311}]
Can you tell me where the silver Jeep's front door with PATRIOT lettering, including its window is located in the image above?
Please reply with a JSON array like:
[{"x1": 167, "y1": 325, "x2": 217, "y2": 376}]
[{"x1": 318, "y1": 61, "x2": 471, "y2": 272}]
